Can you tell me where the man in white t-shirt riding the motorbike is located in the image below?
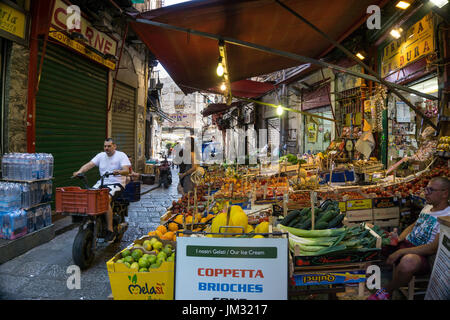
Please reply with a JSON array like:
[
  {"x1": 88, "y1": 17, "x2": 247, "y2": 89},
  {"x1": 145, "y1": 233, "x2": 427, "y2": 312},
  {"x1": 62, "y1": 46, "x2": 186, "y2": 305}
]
[{"x1": 73, "y1": 138, "x2": 131, "y2": 243}]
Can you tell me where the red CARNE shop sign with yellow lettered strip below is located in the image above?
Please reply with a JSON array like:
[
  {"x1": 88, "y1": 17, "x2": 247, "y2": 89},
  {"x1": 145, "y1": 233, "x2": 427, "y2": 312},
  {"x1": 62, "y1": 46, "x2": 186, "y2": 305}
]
[{"x1": 49, "y1": 0, "x2": 117, "y2": 70}]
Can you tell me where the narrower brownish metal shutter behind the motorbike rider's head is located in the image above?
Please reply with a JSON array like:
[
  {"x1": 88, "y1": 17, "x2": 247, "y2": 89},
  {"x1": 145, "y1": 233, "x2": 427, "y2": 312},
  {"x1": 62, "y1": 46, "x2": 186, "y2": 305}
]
[{"x1": 111, "y1": 82, "x2": 136, "y2": 162}]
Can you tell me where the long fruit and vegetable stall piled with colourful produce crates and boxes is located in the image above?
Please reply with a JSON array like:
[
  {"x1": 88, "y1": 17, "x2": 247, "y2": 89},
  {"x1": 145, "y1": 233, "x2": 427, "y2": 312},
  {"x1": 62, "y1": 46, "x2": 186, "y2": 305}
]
[{"x1": 107, "y1": 121, "x2": 450, "y2": 300}]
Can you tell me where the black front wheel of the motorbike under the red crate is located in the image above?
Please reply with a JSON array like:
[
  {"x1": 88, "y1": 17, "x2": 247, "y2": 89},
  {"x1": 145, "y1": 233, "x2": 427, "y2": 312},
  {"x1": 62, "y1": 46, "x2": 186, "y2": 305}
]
[{"x1": 72, "y1": 228, "x2": 95, "y2": 270}]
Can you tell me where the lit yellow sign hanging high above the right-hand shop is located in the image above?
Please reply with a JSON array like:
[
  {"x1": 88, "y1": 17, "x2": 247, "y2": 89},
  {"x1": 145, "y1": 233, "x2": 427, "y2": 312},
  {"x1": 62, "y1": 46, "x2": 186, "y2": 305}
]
[{"x1": 381, "y1": 14, "x2": 434, "y2": 78}]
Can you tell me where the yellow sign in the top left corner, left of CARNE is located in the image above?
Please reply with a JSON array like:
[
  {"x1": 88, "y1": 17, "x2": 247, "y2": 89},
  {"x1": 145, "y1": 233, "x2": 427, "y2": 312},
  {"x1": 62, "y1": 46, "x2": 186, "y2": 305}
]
[{"x1": 0, "y1": 2, "x2": 27, "y2": 40}]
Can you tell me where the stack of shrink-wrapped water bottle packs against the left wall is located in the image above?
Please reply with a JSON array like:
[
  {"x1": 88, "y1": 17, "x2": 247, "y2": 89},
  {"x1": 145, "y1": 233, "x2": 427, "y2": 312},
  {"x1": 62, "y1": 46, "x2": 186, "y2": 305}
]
[{"x1": 0, "y1": 153, "x2": 53, "y2": 239}]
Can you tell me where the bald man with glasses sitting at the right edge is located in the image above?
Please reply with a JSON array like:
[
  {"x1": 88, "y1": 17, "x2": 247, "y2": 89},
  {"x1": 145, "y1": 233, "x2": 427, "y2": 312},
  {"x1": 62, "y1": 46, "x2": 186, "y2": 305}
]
[{"x1": 368, "y1": 177, "x2": 450, "y2": 300}]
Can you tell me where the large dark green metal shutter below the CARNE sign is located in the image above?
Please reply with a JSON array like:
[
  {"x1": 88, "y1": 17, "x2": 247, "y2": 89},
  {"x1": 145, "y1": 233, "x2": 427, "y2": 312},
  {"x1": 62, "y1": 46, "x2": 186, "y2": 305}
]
[{"x1": 36, "y1": 43, "x2": 108, "y2": 191}]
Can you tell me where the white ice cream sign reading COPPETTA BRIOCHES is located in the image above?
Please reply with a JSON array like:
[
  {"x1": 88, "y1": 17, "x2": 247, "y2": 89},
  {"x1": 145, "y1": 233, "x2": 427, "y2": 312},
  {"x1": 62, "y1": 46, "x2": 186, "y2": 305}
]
[{"x1": 175, "y1": 237, "x2": 288, "y2": 300}]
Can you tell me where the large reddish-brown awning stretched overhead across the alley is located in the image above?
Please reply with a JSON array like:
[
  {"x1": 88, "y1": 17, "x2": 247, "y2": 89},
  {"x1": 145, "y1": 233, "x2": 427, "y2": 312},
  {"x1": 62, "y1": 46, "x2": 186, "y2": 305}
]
[{"x1": 130, "y1": 0, "x2": 386, "y2": 93}]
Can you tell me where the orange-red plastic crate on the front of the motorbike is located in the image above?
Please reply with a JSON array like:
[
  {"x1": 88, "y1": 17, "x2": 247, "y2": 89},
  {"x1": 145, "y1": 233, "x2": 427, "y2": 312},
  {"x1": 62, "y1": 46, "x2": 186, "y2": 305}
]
[{"x1": 55, "y1": 187, "x2": 109, "y2": 215}]
